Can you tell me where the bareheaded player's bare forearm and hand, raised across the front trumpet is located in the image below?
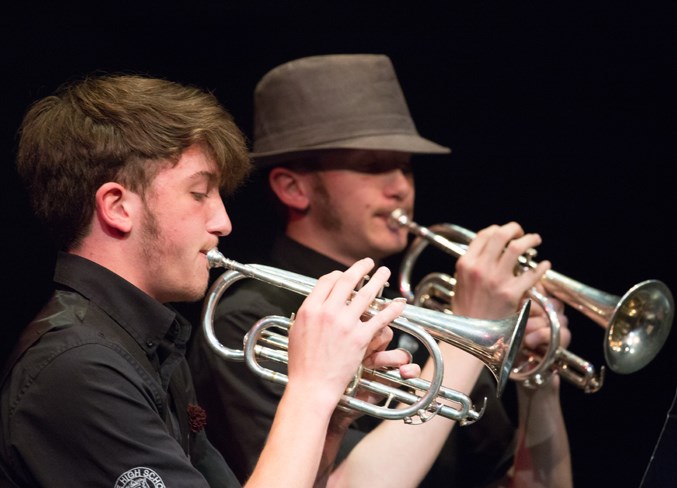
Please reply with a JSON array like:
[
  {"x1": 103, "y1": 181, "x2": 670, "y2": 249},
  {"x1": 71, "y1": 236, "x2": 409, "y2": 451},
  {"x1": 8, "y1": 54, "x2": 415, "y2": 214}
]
[{"x1": 247, "y1": 258, "x2": 406, "y2": 488}]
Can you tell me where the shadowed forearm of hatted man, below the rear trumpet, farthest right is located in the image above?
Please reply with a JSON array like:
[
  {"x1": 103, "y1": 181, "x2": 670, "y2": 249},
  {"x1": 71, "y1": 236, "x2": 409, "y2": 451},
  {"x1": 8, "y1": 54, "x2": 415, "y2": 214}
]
[{"x1": 512, "y1": 378, "x2": 573, "y2": 488}]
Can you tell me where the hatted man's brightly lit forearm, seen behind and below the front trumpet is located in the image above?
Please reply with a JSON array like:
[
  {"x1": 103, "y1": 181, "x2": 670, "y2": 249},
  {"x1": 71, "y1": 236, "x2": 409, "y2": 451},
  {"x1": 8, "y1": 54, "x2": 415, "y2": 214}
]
[{"x1": 329, "y1": 344, "x2": 483, "y2": 488}]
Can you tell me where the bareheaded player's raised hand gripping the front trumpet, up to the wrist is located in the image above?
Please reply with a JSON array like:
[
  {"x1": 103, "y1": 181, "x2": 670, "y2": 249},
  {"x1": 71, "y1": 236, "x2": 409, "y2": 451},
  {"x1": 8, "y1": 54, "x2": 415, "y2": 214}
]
[{"x1": 287, "y1": 258, "x2": 412, "y2": 405}]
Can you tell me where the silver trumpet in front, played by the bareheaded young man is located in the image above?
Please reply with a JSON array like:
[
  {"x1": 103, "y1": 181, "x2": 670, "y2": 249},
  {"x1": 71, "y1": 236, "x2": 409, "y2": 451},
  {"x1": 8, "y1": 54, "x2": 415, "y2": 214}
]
[{"x1": 202, "y1": 249, "x2": 530, "y2": 425}]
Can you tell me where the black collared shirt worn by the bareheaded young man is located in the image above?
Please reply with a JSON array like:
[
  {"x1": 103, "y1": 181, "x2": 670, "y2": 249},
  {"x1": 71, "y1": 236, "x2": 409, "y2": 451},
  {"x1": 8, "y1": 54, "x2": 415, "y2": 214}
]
[{"x1": 0, "y1": 253, "x2": 239, "y2": 488}]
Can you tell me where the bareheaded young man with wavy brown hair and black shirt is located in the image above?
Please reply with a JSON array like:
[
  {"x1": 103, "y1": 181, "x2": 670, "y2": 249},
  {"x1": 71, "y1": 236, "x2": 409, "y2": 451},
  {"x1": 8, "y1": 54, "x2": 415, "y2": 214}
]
[{"x1": 0, "y1": 75, "x2": 418, "y2": 488}]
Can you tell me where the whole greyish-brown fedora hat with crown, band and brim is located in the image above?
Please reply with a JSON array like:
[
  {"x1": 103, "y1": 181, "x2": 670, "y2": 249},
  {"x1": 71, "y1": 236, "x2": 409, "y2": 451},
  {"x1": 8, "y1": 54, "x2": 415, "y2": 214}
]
[{"x1": 251, "y1": 54, "x2": 450, "y2": 167}]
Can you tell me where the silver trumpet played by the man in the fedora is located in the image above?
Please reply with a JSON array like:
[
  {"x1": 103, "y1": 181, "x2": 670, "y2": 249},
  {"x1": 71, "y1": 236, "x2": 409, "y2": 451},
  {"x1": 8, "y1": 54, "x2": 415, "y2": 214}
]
[{"x1": 390, "y1": 209, "x2": 675, "y2": 393}]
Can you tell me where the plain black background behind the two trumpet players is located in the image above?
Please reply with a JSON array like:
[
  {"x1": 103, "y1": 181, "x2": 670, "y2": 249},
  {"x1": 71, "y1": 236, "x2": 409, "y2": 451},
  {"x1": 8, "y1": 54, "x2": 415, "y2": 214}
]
[{"x1": 0, "y1": 0, "x2": 677, "y2": 487}]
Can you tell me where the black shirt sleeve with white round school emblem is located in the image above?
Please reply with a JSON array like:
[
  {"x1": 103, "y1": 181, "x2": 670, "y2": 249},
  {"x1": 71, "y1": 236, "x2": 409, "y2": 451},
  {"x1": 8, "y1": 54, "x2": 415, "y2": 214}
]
[{"x1": 9, "y1": 343, "x2": 209, "y2": 488}]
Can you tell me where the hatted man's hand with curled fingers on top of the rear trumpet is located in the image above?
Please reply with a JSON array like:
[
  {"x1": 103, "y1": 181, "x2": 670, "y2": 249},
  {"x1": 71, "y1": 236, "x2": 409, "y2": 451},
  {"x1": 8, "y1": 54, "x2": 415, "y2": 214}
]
[{"x1": 452, "y1": 222, "x2": 550, "y2": 319}]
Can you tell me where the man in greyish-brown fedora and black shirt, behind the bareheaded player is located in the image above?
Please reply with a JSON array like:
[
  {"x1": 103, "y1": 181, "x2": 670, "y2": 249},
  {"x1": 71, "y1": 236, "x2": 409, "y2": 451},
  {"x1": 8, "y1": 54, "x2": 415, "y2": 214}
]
[{"x1": 190, "y1": 54, "x2": 571, "y2": 487}]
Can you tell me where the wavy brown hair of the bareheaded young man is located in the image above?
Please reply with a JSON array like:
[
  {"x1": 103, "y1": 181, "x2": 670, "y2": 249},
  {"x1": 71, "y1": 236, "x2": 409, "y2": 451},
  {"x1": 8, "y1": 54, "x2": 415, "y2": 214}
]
[{"x1": 17, "y1": 75, "x2": 251, "y2": 249}]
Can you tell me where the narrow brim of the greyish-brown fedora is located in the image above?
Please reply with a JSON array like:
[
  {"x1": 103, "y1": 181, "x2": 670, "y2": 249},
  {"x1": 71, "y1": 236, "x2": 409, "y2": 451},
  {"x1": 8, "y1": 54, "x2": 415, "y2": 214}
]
[{"x1": 249, "y1": 134, "x2": 451, "y2": 168}]
